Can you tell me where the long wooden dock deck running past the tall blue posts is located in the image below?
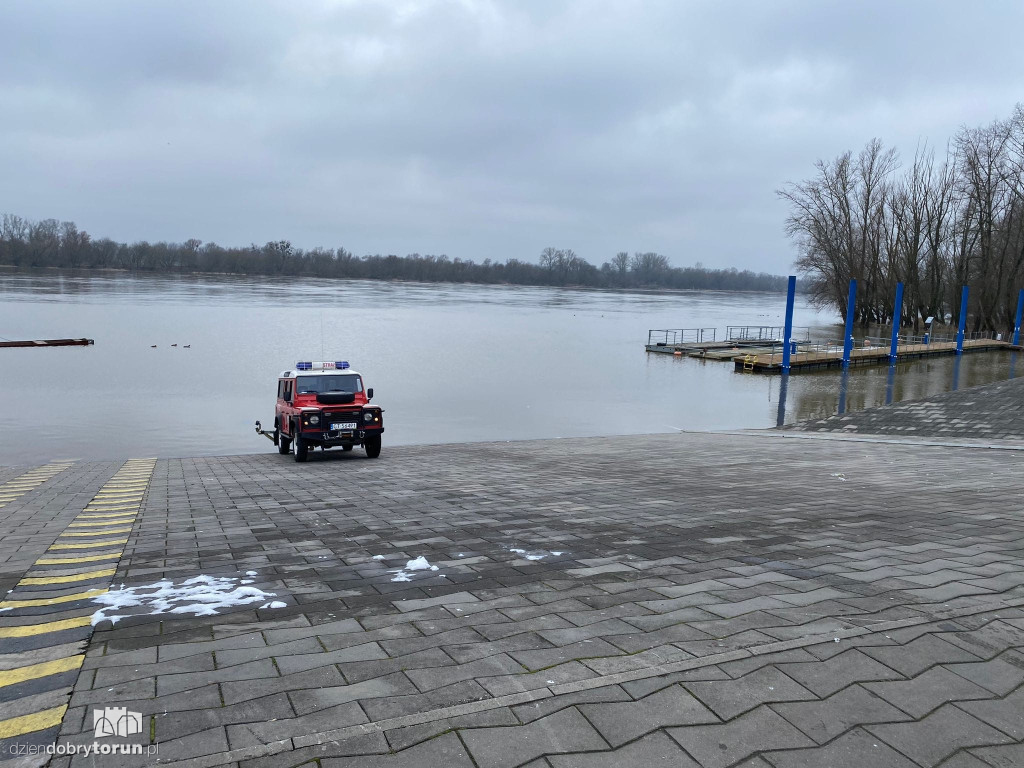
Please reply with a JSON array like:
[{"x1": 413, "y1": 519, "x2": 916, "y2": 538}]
[{"x1": 733, "y1": 339, "x2": 1024, "y2": 374}]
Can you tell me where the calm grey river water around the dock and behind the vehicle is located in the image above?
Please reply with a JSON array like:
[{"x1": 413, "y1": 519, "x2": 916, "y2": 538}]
[{"x1": 0, "y1": 272, "x2": 1015, "y2": 464}]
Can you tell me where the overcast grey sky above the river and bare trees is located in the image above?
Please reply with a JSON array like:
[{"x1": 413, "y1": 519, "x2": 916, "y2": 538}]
[{"x1": 0, "y1": 0, "x2": 1024, "y2": 273}]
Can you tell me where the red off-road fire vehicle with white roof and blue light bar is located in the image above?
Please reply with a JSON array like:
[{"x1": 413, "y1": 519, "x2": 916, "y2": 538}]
[{"x1": 256, "y1": 360, "x2": 384, "y2": 462}]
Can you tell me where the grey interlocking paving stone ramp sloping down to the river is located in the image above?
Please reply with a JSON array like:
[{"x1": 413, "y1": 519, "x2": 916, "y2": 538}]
[{"x1": 0, "y1": 385, "x2": 1024, "y2": 768}]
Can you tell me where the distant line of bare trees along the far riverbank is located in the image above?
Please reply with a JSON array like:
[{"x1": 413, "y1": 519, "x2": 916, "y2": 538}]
[{"x1": 0, "y1": 214, "x2": 785, "y2": 291}]
